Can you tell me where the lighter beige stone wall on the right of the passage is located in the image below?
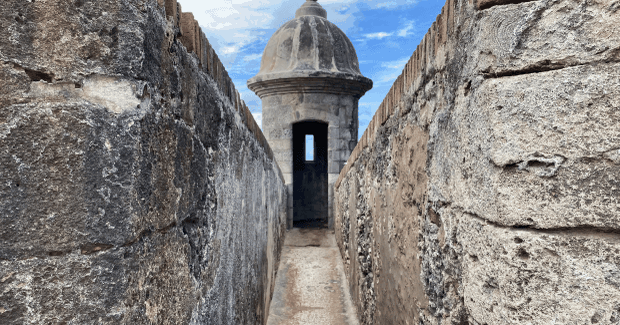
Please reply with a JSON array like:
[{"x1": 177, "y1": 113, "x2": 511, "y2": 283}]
[{"x1": 334, "y1": 0, "x2": 620, "y2": 324}]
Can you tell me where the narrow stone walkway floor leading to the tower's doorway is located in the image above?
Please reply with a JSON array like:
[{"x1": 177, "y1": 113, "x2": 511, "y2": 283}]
[{"x1": 267, "y1": 228, "x2": 359, "y2": 325}]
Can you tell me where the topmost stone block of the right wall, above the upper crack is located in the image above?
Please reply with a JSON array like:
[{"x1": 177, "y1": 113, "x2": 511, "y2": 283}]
[{"x1": 466, "y1": 1, "x2": 620, "y2": 76}]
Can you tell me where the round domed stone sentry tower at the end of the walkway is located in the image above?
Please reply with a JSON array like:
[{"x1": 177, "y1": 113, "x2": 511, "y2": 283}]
[{"x1": 248, "y1": 0, "x2": 372, "y2": 228}]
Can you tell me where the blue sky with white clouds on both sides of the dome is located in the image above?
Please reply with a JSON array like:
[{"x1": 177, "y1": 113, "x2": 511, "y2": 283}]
[{"x1": 179, "y1": 0, "x2": 445, "y2": 137}]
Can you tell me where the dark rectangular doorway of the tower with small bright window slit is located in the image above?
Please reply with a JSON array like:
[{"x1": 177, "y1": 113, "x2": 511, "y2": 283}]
[{"x1": 293, "y1": 122, "x2": 328, "y2": 228}]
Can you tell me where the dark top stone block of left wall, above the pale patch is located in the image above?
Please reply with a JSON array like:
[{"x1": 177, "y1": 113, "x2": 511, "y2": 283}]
[{"x1": 0, "y1": 0, "x2": 154, "y2": 82}]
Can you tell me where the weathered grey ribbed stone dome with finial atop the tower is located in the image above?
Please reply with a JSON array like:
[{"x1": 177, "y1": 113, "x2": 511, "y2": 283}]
[{"x1": 248, "y1": 0, "x2": 372, "y2": 96}]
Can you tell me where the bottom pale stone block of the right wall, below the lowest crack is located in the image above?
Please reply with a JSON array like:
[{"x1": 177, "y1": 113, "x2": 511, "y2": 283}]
[{"x1": 457, "y1": 214, "x2": 620, "y2": 324}]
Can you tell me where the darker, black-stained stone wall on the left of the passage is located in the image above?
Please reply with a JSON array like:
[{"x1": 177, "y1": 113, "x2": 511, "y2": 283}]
[{"x1": 0, "y1": 0, "x2": 287, "y2": 324}]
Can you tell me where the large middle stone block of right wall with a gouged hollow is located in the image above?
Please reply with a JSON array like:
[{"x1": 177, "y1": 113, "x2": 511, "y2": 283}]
[{"x1": 433, "y1": 64, "x2": 620, "y2": 229}]
